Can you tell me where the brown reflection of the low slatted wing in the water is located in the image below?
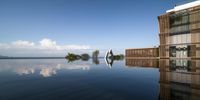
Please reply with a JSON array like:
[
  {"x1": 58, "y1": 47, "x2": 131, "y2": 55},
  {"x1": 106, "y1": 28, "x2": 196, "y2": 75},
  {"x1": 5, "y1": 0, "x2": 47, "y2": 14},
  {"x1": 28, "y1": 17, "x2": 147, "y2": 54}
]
[{"x1": 126, "y1": 59, "x2": 159, "y2": 68}]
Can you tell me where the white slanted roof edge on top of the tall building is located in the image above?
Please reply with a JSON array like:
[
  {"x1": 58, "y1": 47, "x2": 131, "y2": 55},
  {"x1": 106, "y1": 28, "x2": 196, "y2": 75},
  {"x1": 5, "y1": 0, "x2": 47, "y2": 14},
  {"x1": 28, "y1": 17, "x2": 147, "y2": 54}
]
[{"x1": 166, "y1": 0, "x2": 200, "y2": 13}]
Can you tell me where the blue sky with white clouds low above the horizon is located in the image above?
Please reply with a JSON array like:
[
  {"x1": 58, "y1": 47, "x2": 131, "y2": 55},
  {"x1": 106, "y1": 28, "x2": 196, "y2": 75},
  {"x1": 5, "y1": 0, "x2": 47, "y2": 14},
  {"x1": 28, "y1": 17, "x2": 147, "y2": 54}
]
[{"x1": 0, "y1": 0, "x2": 185, "y2": 56}]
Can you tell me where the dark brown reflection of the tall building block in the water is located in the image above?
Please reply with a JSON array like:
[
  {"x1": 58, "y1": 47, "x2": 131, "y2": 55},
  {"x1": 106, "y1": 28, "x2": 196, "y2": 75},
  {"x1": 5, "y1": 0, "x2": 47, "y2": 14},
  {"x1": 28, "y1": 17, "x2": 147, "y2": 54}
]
[{"x1": 159, "y1": 60, "x2": 200, "y2": 100}]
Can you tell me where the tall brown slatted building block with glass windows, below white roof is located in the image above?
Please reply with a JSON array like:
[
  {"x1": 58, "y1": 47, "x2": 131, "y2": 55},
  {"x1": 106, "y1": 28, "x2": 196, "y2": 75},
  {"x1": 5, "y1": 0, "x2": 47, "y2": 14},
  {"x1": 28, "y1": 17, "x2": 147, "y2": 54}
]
[{"x1": 158, "y1": 6, "x2": 200, "y2": 58}]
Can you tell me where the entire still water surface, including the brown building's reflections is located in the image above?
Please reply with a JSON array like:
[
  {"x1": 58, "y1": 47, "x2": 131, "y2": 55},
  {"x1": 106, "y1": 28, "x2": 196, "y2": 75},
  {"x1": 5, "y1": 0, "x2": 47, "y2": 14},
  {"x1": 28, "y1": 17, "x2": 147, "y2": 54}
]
[{"x1": 0, "y1": 59, "x2": 200, "y2": 100}]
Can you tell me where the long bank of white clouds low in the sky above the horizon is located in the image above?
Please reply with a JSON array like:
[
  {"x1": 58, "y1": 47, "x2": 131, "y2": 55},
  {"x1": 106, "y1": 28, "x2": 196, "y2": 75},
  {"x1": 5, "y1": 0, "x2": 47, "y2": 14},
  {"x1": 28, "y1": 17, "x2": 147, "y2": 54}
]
[{"x1": 0, "y1": 38, "x2": 90, "y2": 56}]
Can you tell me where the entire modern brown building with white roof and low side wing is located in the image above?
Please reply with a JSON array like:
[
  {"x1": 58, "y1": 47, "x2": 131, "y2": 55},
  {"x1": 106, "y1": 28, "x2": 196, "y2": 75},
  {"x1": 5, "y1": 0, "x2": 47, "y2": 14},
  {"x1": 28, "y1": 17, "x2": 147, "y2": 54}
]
[{"x1": 125, "y1": 0, "x2": 200, "y2": 59}]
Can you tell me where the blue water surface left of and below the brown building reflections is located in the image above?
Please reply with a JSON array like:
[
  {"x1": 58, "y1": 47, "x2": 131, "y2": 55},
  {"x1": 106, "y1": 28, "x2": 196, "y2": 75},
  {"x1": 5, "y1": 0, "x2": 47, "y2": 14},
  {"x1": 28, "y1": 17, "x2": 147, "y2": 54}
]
[{"x1": 0, "y1": 59, "x2": 158, "y2": 100}]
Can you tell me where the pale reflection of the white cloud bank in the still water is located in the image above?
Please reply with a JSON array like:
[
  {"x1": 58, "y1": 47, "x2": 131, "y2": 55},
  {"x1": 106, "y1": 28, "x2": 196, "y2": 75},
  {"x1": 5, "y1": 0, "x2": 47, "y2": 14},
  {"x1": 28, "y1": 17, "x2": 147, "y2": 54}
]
[{"x1": 0, "y1": 60, "x2": 90, "y2": 77}]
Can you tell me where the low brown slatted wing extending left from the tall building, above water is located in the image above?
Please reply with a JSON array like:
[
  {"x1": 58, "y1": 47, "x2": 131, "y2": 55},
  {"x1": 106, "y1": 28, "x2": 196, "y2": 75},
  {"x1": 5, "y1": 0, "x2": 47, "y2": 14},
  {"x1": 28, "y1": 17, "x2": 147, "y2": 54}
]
[{"x1": 126, "y1": 48, "x2": 159, "y2": 59}]
